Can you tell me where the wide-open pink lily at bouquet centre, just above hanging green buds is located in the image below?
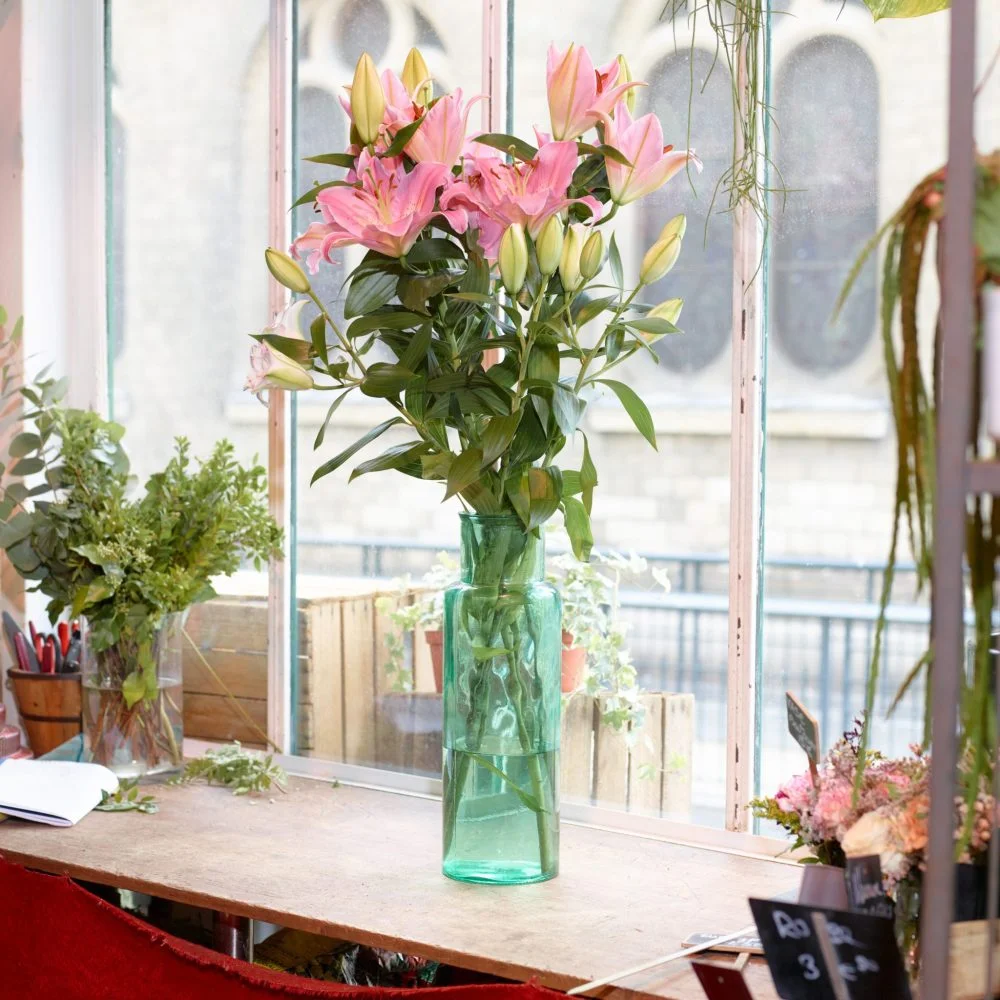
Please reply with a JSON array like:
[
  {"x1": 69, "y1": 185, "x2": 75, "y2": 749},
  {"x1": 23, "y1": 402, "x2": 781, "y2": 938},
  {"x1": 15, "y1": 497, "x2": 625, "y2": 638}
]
[{"x1": 441, "y1": 142, "x2": 601, "y2": 261}]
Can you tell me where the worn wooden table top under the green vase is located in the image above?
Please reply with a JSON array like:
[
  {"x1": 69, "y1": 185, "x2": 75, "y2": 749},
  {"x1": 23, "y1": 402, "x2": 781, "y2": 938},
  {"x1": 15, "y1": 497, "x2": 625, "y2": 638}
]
[{"x1": 0, "y1": 779, "x2": 799, "y2": 1000}]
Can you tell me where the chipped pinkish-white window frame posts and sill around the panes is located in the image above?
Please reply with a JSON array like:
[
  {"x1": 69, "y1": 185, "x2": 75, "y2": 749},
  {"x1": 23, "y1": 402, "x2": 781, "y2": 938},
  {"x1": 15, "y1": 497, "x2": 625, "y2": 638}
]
[{"x1": 9, "y1": 0, "x2": 787, "y2": 855}]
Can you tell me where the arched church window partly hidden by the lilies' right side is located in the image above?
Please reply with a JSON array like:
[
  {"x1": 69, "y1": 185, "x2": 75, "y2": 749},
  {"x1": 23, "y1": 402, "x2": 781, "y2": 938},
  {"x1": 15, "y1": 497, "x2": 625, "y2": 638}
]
[{"x1": 639, "y1": 49, "x2": 733, "y2": 372}]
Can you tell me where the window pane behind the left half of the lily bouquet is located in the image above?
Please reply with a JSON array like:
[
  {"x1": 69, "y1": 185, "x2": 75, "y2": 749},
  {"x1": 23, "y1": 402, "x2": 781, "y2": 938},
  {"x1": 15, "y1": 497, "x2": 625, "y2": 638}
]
[{"x1": 294, "y1": 0, "x2": 482, "y2": 764}]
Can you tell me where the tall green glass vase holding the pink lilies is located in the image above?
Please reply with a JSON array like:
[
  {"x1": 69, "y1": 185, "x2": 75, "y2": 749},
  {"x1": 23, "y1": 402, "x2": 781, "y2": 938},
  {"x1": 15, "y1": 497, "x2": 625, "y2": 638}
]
[{"x1": 444, "y1": 514, "x2": 562, "y2": 885}]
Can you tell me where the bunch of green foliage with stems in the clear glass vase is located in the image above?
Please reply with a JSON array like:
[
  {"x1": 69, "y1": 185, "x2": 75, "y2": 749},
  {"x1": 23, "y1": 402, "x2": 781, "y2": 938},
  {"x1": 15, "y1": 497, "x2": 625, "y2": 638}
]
[{"x1": 0, "y1": 378, "x2": 281, "y2": 763}]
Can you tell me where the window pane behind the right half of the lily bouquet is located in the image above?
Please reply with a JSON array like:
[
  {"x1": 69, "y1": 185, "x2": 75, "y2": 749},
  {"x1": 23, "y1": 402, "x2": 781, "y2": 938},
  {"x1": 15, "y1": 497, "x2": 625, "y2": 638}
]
[{"x1": 514, "y1": 7, "x2": 732, "y2": 826}]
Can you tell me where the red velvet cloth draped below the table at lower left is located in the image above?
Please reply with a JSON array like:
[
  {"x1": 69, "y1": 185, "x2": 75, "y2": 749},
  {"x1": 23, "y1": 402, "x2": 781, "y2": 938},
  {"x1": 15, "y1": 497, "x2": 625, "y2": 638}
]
[{"x1": 0, "y1": 858, "x2": 562, "y2": 1000}]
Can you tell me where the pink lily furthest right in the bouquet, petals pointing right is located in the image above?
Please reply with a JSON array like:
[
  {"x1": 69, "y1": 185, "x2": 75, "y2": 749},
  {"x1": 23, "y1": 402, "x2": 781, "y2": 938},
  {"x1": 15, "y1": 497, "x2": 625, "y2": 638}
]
[{"x1": 604, "y1": 101, "x2": 701, "y2": 205}]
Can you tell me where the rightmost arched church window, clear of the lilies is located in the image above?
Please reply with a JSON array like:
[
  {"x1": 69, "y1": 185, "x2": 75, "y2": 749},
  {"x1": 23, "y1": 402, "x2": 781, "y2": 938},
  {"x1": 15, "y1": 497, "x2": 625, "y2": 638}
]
[{"x1": 771, "y1": 36, "x2": 879, "y2": 375}]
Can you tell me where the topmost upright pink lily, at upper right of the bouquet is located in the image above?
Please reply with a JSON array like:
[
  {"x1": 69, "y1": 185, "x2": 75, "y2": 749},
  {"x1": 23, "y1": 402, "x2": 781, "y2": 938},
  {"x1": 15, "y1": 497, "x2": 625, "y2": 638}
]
[{"x1": 545, "y1": 43, "x2": 645, "y2": 139}]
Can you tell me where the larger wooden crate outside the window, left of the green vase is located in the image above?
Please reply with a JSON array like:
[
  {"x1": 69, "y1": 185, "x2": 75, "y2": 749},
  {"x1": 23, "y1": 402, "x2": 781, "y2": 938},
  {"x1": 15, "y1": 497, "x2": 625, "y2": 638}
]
[{"x1": 183, "y1": 580, "x2": 433, "y2": 765}]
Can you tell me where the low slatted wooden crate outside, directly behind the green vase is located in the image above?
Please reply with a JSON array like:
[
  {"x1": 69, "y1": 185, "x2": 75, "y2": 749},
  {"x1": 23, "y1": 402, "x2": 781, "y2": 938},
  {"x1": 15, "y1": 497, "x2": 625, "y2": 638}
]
[{"x1": 376, "y1": 692, "x2": 694, "y2": 819}]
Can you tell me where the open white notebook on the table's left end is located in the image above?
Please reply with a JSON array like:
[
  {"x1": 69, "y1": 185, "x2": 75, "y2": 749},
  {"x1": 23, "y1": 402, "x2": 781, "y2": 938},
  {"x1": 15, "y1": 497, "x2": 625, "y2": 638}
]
[{"x1": 0, "y1": 760, "x2": 118, "y2": 826}]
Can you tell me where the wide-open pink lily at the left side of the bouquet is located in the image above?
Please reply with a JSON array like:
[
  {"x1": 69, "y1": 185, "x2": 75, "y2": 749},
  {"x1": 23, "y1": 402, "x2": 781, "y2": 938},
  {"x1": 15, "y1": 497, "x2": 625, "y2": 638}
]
[{"x1": 292, "y1": 151, "x2": 468, "y2": 264}]
